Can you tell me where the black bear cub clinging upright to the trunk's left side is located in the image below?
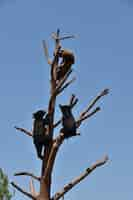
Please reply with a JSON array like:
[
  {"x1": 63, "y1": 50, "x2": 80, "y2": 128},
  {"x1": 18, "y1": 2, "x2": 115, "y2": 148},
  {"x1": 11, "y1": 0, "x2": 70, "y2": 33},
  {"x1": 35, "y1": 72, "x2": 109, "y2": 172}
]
[{"x1": 33, "y1": 110, "x2": 51, "y2": 159}]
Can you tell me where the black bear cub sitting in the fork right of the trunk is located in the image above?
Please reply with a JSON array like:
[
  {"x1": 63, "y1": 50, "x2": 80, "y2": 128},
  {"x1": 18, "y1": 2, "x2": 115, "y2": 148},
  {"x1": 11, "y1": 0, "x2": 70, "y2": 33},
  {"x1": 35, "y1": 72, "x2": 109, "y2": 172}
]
[{"x1": 59, "y1": 105, "x2": 77, "y2": 138}]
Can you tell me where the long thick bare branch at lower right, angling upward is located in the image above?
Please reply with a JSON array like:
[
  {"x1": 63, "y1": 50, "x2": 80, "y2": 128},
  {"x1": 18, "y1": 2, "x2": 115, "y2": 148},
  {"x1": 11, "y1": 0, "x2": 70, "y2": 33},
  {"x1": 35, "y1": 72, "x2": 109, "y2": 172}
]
[{"x1": 52, "y1": 156, "x2": 108, "y2": 200}]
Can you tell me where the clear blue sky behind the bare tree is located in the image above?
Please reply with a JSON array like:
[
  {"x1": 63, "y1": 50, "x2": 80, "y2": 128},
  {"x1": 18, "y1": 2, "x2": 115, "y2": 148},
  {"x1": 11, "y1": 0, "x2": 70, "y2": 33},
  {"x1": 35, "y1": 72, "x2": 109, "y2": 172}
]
[{"x1": 0, "y1": 0, "x2": 133, "y2": 200}]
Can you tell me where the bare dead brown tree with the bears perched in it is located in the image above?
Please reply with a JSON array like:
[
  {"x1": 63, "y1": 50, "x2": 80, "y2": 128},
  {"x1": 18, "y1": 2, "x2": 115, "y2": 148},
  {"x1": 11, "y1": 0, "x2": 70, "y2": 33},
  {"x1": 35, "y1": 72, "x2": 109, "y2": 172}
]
[{"x1": 11, "y1": 30, "x2": 109, "y2": 200}]
